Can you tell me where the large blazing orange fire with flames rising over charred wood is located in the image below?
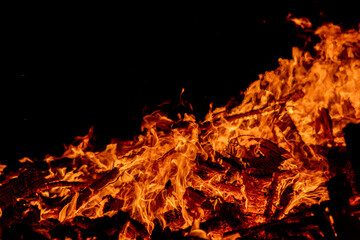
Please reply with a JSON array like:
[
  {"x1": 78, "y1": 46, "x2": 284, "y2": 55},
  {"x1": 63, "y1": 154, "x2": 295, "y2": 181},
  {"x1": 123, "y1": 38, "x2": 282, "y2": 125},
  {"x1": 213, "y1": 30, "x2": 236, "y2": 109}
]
[{"x1": 0, "y1": 16, "x2": 360, "y2": 239}]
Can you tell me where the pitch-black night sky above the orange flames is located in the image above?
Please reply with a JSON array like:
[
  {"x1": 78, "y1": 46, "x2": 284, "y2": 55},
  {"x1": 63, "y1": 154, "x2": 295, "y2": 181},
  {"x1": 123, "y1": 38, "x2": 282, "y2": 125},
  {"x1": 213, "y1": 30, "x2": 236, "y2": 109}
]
[{"x1": 5, "y1": 1, "x2": 360, "y2": 162}]
